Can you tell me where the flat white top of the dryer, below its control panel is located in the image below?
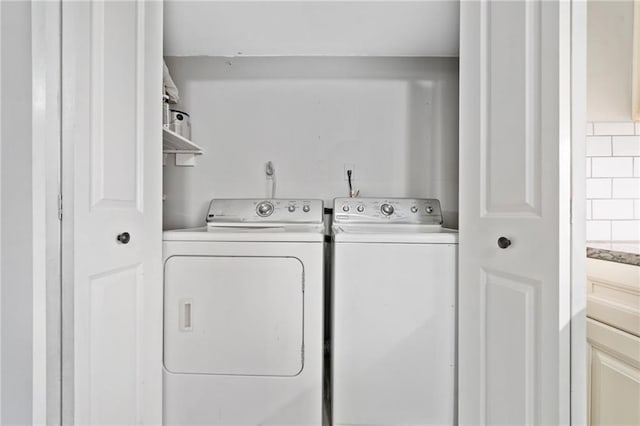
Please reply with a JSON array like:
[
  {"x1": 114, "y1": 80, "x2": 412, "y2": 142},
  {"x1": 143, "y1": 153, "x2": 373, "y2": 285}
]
[{"x1": 162, "y1": 224, "x2": 324, "y2": 242}]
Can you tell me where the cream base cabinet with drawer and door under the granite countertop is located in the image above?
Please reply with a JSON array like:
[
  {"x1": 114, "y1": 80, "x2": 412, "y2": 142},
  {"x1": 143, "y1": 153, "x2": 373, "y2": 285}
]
[{"x1": 587, "y1": 259, "x2": 640, "y2": 426}]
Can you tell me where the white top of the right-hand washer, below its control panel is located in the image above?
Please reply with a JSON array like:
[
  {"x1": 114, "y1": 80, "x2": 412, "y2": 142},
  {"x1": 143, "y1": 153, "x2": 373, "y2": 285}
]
[{"x1": 332, "y1": 224, "x2": 458, "y2": 244}]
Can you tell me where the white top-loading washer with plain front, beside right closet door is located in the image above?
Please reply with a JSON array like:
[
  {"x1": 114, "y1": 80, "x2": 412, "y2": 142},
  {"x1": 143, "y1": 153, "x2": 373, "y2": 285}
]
[{"x1": 332, "y1": 198, "x2": 458, "y2": 426}]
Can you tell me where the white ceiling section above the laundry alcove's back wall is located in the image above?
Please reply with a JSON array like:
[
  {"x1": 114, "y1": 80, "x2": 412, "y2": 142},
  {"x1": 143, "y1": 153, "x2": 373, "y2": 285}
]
[{"x1": 164, "y1": 0, "x2": 460, "y2": 56}]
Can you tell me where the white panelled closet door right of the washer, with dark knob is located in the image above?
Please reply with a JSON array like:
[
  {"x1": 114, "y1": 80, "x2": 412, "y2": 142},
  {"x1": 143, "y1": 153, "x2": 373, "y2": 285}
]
[{"x1": 459, "y1": 0, "x2": 571, "y2": 425}]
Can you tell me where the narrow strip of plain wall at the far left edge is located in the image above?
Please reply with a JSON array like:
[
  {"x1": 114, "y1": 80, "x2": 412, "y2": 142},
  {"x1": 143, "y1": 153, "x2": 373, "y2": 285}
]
[{"x1": 0, "y1": 2, "x2": 33, "y2": 425}]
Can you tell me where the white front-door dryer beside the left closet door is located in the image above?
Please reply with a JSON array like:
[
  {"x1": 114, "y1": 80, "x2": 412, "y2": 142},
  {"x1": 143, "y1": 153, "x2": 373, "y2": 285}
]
[{"x1": 164, "y1": 199, "x2": 324, "y2": 426}]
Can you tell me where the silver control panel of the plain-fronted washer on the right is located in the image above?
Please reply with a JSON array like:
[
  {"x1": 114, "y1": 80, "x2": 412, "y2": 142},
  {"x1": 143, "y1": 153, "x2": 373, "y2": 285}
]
[{"x1": 333, "y1": 198, "x2": 442, "y2": 225}]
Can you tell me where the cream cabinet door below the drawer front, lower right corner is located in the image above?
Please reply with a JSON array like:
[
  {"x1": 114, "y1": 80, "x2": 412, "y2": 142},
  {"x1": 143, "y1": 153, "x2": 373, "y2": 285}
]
[{"x1": 587, "y1": 319, "x2": 640, "y2": 426}]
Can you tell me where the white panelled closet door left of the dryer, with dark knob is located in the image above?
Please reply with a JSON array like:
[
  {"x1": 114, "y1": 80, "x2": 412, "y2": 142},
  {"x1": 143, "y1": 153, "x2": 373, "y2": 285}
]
[{"x1": 62, "y1": 0, "x2": 162, "y2": 425}]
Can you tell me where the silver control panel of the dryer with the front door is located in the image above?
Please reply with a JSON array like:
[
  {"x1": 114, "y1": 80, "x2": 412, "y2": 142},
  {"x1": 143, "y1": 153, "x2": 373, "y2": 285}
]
[{"x1": 207, "y1": 198, "x2": 324, "y2": 225}]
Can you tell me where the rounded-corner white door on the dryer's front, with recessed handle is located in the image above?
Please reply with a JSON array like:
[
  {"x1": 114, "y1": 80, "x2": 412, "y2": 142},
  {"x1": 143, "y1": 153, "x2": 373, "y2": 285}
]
[{"x1": 164, "y1": 256, "x2": 304, "y2": 376}]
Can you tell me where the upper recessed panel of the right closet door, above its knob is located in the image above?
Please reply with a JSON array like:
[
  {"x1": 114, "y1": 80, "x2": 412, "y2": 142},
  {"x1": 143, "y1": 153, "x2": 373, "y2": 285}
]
[{"x1": 479, "y1": 1, "x2": 541, "y2": 216}]
